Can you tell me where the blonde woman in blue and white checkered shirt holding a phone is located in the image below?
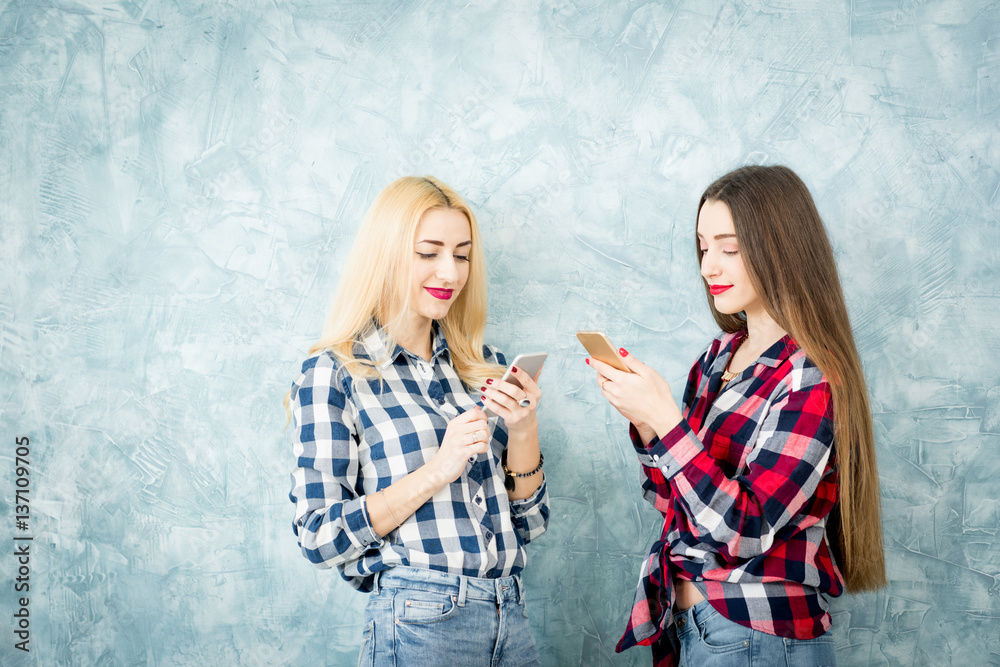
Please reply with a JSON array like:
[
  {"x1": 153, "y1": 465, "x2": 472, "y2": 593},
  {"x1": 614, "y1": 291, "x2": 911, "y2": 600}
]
[{"x1": 289, "y1": 177, "x2": 548, "y2": 665}]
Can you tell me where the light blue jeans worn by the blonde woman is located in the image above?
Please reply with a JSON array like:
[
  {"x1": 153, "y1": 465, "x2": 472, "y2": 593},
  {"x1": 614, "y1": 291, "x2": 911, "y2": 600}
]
[{"x1": 358, "y1": 567, "x2": 541, "y2": 667}]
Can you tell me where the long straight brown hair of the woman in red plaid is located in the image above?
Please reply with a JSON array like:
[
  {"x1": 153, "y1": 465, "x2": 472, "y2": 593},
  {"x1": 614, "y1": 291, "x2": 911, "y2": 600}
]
[{"x1": 695, "y1": 166, "x2": 886, "y2": 591}]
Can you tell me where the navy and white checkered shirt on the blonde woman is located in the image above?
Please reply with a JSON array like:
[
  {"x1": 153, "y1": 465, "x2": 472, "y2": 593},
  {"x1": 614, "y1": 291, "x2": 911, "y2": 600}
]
[{"x1": 289, "y1": 327, "x2": 549, "y2": 592}]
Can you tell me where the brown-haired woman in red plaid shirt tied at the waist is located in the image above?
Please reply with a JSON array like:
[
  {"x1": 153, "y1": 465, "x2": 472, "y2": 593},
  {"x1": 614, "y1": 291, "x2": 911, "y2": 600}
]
[{"x1": 587, "y1": 166, "x2": 885, "y2": 667}]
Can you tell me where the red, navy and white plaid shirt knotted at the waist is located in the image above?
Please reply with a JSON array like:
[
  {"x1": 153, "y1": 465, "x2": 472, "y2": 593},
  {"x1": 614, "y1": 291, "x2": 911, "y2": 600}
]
[{"x1": 616, "y1": 333, "x2": 844, "y2": 667}]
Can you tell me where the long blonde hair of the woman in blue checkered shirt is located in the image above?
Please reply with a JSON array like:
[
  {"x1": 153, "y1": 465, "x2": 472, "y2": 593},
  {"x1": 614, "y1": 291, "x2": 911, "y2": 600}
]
[{"x1": 309, "y1": 176, "x2": 503, "y2": 387}]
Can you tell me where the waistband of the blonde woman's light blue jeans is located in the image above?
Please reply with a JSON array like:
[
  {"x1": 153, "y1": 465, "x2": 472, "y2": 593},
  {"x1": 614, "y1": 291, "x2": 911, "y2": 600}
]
[{"x1": 372, "y1": 565, "x2": 524, "y2": 607}]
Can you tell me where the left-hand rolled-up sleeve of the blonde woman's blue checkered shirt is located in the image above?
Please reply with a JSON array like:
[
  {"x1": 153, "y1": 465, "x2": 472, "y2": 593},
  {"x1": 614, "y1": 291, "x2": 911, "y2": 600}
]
[{"x1": 288, "y1": 354, "x2": 382, "y2": 568}]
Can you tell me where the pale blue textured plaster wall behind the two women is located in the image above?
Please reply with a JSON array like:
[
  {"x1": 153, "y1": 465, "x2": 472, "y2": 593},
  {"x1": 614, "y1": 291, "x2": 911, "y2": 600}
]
[{"x1": 0, "y1": 0, "x2": 1000, "y2": 667}]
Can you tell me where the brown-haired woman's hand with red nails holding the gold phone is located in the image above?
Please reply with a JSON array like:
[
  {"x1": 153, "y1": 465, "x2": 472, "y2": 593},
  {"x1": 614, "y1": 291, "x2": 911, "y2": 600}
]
[{"x1": 587, "y1": 348, "x2": 681, "y2": 444}]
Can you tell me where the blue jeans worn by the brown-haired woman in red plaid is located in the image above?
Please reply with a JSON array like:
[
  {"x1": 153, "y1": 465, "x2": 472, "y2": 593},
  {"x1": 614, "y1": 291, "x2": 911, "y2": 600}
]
[{"x1": 674, "y1": 600, "x2": 837, "y2": 667}]
